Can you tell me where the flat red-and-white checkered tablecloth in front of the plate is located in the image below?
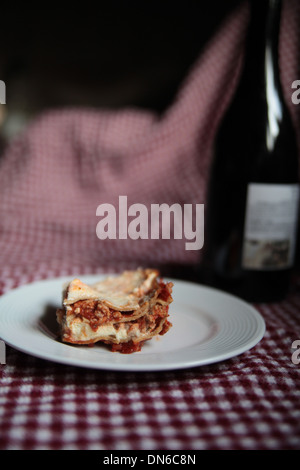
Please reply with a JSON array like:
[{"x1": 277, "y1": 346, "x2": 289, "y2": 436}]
[{"x1": 0, "y1": 276, "x2": 300, "y2": 450}]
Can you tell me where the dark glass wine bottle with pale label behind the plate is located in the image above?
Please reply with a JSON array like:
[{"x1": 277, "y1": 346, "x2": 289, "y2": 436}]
[{"x1": 202, "y1": 0, "x2": 299, "y2": 302}]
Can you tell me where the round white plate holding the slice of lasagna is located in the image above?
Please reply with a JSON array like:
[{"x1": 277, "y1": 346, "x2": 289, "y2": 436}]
[{"x1": 0, "y1": 275, "x2": 265, "y2": 371}]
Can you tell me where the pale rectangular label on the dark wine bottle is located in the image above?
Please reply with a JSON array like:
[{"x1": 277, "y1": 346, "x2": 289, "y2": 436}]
[{"x1": 242, "y1": 183, "x2": 299, "y2": 270}]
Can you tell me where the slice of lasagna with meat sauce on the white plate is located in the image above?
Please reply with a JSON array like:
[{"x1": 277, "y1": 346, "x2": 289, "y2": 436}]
[{"x1": 57, "y1": 269, "x2": 173, "y2": 353}]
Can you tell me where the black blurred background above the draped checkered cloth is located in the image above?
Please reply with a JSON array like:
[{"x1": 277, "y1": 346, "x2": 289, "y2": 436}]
[{"x1": 0, "y1": 0, "x2": 240, "y2": 140}]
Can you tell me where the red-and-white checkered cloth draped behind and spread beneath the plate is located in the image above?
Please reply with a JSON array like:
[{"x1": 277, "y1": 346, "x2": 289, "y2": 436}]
[{"x1": 0, "y1": 0, "x2": 300, "y2": 450}]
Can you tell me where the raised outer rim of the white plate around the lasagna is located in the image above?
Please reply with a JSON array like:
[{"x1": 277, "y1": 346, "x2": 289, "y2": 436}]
[{"x1": 0, "y1": 271, "x2": 266, "y2": 372}]
